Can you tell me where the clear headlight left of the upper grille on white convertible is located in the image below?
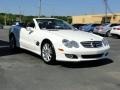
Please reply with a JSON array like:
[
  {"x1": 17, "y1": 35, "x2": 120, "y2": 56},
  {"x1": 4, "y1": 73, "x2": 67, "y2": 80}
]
[{"x1": 62, "y1": 39, "x2": 79, "y2": 48}]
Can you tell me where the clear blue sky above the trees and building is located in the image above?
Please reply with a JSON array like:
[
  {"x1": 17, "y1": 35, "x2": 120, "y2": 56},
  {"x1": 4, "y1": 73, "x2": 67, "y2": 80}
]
[{"x1": 0, "y1": 0, "x2": 120, "y2": 16}]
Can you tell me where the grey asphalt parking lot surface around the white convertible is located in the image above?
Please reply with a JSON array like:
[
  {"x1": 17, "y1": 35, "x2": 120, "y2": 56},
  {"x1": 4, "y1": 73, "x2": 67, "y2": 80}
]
[{"x1": 0, "y1": 29, "x2": 120, "y2": 90}]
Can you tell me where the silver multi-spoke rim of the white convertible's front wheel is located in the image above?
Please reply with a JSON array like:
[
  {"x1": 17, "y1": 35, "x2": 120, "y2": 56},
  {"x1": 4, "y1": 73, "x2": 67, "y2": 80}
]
[{"x1": 42, "y1": 44, "x2": 53, "y2": 62}]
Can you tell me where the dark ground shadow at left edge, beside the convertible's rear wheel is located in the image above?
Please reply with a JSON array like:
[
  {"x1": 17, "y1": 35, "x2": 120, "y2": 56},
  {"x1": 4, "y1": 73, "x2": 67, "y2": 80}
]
[{"x1": 0, "y1": 40, "x2": 21, "y2": 57}]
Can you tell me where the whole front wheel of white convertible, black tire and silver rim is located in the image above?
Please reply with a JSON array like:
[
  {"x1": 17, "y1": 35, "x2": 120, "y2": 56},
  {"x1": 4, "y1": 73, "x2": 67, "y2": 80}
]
[{"x1": 41, "y1": 42, "x2": 56, "y2": 64}]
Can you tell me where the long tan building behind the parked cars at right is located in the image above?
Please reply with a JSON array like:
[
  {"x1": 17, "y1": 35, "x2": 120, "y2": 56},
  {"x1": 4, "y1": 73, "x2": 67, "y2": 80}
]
[{"x1": 72, "y1": 13, "x2": 120, "y2": 24}]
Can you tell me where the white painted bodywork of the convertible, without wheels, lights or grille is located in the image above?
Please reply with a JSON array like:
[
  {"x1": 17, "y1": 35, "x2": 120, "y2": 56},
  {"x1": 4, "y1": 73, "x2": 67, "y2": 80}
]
[{"x1": 10, "y1": 19, "x2": 110, "y2": 62}]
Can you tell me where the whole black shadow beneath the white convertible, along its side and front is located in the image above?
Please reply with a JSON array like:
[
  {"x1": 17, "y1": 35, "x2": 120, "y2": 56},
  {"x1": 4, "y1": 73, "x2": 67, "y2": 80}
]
[{"x1": 12, "y1": 49, "x2": 113, "y2": 68}]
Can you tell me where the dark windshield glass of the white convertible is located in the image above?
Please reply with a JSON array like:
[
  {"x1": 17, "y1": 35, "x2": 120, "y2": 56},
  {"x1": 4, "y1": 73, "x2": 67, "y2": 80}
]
[{"x1": 37, "y1": 19, "x2": 74, "y2": 30}]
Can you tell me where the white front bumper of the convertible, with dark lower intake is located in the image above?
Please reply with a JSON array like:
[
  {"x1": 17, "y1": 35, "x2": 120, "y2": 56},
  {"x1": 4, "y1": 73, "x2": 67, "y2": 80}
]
[{"x1": 56, "y1": 47, "x2": 110, "y2": 62}]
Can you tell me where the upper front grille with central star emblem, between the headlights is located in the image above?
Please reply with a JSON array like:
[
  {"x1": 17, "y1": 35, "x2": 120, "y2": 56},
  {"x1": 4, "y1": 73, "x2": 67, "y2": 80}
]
[{"x1": 81, "y1": 41, "x2": 102, "y2": 48}]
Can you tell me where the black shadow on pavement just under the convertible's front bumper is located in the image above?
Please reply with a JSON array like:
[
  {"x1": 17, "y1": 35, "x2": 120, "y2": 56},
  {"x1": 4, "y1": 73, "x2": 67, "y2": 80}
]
[{"x1": 59, "y1": 58, "x2": 113, "y2": 68}]
